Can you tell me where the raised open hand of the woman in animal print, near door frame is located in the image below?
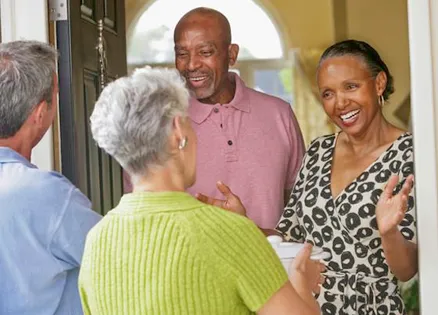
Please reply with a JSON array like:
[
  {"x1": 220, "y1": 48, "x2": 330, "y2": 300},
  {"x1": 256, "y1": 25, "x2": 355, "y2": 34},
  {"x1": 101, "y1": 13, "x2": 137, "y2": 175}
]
[{"x1": 376, "y1": 175, "x2": 414, "y2": 236}]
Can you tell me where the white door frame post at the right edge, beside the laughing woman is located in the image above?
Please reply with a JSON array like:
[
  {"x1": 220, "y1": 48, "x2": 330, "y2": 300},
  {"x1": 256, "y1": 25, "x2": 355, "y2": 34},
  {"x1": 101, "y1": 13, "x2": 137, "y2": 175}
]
[{"x1": 408, "y1": 0, "x2": 438, "y2": 315}]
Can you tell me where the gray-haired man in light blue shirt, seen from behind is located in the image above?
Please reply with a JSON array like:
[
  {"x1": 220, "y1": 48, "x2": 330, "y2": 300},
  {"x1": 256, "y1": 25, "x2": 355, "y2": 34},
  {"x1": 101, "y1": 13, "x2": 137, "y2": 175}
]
[{"x1": 0, "y1": 41, "x2": 100, "y2": 315}]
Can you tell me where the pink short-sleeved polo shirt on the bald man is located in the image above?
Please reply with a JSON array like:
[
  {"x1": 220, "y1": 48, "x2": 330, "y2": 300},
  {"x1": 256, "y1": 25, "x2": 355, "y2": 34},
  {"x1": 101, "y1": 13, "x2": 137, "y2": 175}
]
[{"x1": 188, "y1": 73, "x2": 304, "y2": 229}]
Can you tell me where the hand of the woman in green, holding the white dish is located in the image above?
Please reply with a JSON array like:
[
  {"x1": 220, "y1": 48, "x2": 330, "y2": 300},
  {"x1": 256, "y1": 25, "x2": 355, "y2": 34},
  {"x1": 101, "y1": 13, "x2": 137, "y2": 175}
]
[{"x1": 289, "y1": 243, "x2": 325, "y2": 293}]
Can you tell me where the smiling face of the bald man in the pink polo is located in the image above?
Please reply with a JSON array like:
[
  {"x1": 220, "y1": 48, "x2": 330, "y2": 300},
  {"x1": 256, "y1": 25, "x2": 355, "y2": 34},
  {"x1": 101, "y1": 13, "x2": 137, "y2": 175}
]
[{"x1": 174, "y1": 14, "x2": 238, "y2": 104}]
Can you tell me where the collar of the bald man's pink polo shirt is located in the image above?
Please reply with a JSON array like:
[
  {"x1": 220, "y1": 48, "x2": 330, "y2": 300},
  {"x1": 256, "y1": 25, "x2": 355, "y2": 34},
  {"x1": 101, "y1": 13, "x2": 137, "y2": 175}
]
[{"x1": 189, "y1": 72, "x2": 250, "y2": 124}]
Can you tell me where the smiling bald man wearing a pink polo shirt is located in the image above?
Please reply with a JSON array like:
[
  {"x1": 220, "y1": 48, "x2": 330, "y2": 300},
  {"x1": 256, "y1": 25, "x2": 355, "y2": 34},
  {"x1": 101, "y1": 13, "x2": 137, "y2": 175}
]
[{"x1": 174, "y1": 8, "x2": 304, "y2": 229}]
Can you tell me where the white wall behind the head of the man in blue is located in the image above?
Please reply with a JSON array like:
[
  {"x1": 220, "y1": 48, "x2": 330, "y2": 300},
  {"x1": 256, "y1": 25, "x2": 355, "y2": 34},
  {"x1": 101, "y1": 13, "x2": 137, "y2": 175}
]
[{"x1": 0, "y1": 0, "x2": 54, "y2": 170}]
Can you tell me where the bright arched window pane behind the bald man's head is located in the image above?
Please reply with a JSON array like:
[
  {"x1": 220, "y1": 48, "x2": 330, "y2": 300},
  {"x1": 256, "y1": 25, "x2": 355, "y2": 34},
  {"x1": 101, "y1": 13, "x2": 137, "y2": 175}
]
[{"x1": 128, "y1": 0, "x2": 283, "y2": 64}]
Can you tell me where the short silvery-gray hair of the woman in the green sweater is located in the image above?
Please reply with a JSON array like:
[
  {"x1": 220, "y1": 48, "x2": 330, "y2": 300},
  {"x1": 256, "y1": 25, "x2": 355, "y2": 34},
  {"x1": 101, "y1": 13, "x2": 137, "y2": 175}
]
[{"x1": 90, "y1": 67, "x2": 189, "y2": 175}]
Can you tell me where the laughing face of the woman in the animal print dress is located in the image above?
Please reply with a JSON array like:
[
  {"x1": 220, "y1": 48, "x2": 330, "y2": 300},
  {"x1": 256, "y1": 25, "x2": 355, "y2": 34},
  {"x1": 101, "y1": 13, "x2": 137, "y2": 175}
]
[{"x1": 317, "y1": 55, "x2": 386, "y2": 135}]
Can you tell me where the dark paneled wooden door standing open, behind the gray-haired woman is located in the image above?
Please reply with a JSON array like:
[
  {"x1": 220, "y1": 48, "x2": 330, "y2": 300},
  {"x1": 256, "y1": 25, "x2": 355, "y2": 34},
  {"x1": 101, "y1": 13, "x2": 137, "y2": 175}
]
[{"x1": 56, "y1": 0, "x2": 126, "y2": 214}]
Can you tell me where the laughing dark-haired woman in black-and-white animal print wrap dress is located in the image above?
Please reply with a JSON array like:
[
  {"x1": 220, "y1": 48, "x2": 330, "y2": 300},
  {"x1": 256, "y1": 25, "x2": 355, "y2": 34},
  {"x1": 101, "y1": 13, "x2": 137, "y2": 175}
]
[{"x1": 200, "y1": 40, "x2": 418, "y2": 315}]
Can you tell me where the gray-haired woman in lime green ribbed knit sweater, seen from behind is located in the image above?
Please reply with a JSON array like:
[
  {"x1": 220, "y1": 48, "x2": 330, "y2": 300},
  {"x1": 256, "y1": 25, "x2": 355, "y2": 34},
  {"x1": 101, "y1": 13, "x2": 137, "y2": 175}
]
[{"x1": 79, "y1": 68, "x2": 322, "y2": 315}]
